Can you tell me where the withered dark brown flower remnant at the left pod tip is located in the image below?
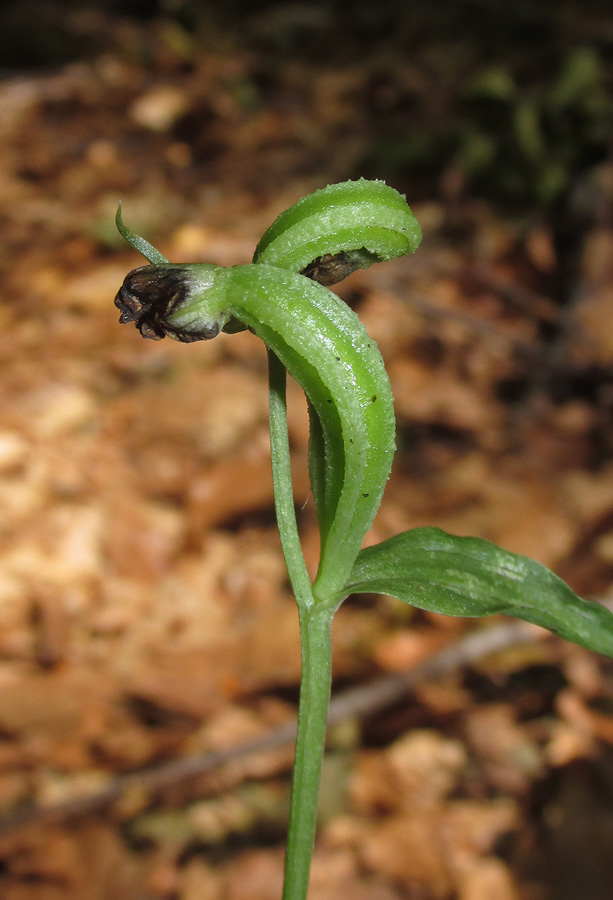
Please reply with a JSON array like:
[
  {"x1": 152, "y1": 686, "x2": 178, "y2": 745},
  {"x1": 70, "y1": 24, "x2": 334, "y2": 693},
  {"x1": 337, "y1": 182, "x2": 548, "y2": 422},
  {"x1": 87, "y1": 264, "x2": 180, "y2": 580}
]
[{"x1": 115, "y1": 265, "x2": 219, "y2": 343}]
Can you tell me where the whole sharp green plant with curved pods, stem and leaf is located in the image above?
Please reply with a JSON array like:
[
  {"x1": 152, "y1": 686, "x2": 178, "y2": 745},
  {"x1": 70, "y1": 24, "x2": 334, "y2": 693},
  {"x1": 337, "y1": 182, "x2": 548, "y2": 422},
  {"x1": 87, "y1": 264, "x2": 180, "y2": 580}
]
[{"x1": 115, "y1": 179, "x2": 613, "y2": 900}]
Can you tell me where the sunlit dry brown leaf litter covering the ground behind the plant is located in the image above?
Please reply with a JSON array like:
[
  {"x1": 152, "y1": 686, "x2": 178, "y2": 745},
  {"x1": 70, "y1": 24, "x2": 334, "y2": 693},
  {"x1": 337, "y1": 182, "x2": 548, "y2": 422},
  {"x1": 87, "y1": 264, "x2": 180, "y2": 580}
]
[{"x1": 0, "y1": 24, "x2": 613, "y2": 900}]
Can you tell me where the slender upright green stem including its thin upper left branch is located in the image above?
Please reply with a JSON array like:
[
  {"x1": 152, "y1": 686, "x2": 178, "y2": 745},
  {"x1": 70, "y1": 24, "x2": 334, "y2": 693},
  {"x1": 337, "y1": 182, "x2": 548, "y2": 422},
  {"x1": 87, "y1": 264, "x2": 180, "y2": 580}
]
[{"x1": 268, "y1": 350, "x2": 336, "y2": 900}]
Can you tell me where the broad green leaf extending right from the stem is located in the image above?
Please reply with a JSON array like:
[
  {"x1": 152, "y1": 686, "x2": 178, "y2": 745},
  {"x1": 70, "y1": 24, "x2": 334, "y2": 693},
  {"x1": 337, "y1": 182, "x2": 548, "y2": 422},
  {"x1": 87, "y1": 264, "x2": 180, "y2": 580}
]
[{"x1": 346, "y1": 528, "x2": 613, "y2": 657}]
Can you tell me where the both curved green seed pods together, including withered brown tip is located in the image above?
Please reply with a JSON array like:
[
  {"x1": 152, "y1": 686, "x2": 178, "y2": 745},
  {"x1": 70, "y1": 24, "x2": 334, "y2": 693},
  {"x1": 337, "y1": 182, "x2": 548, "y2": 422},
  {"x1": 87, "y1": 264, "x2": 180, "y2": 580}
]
[{"x1": 115, "y1": 179, "x2": 421, "y2": 598}]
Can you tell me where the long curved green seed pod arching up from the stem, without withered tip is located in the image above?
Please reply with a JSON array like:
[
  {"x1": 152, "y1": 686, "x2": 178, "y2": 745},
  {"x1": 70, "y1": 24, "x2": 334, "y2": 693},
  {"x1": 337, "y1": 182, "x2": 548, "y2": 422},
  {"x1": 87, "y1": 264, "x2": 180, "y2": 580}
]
[{"x1": 206, "y1": 264, "x2": 395, "y2": 597}]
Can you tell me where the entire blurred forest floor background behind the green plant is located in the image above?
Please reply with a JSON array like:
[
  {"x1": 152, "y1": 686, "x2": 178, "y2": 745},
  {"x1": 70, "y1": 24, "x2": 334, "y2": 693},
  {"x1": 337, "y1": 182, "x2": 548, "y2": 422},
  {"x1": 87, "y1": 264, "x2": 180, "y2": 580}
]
[{"x1": 0, "y1": 0, "x2": 613, "y2": 900}]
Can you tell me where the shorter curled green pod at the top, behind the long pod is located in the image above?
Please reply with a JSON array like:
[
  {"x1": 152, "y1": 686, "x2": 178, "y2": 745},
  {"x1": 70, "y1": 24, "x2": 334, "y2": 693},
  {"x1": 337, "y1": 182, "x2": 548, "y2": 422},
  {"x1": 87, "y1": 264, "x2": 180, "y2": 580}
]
[{"x1": 253, "y1": 178, "x2": 421, "y2": 284}]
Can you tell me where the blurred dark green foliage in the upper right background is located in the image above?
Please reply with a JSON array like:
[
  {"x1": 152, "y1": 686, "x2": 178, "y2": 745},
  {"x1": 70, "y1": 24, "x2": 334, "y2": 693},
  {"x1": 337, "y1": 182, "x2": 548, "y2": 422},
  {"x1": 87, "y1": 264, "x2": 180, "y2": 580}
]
[{"x1": 456, "y1": 47, "x2": 613, "y2": 209}]
